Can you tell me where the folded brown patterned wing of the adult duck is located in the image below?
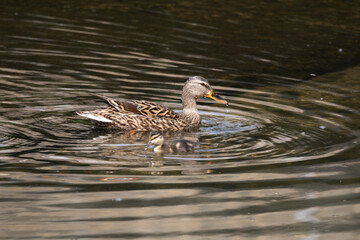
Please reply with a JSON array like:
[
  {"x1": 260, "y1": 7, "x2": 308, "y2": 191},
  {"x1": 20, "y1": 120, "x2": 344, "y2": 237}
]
[{"x1": 97, "y1": 95, "x2": 180, "y2": 119}]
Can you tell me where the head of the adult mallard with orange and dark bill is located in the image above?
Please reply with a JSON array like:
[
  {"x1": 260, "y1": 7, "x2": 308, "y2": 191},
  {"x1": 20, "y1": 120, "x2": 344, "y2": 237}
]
[{"x1": 183, "y1": 76, "x2": 227, "y2": 104}]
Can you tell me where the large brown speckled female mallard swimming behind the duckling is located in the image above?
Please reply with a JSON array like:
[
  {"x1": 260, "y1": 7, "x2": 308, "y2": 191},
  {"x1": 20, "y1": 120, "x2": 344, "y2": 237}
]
[{"x1": 77, "y1": 76, "x2": 227, "y2": 131}]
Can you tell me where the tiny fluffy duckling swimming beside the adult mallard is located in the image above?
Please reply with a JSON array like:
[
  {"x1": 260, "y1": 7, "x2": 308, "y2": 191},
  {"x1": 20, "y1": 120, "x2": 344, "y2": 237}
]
[{"x1": 146, "y1": 132, "x2": 200, "y2": 153}]
